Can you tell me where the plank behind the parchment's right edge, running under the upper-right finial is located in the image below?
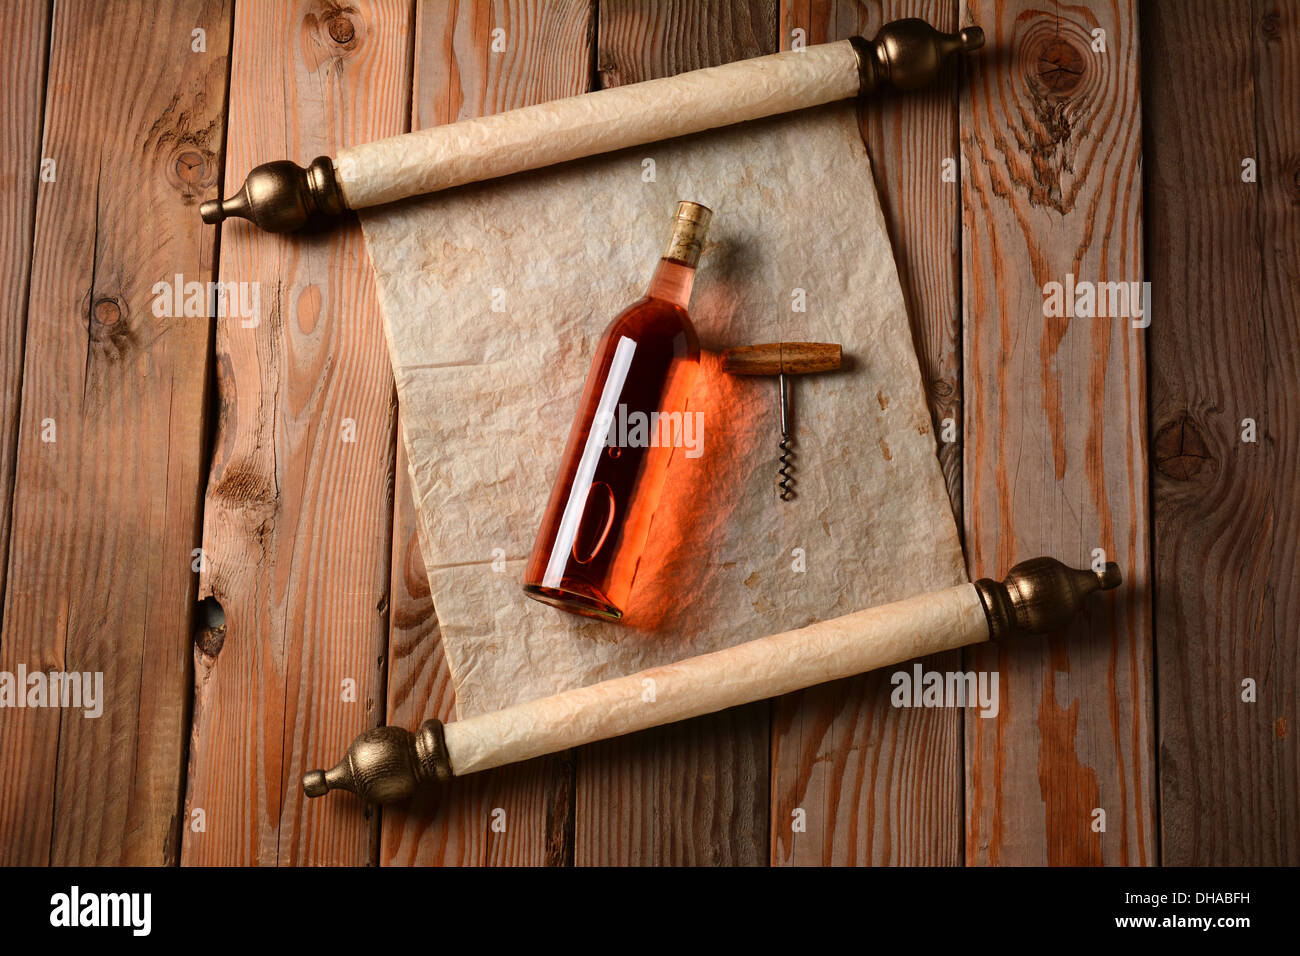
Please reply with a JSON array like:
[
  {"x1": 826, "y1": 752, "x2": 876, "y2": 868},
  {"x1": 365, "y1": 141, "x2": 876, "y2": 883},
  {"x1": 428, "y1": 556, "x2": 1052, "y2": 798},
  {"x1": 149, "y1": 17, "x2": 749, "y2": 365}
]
[{"x1": 771, "y1": 0, "x2": 962, "y2": 865}]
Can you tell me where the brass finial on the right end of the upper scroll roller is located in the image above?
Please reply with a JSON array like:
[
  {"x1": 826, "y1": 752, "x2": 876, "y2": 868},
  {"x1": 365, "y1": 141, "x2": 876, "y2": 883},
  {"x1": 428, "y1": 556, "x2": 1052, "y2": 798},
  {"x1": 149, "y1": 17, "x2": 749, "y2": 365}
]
[{"x1": 849, "y1": 17, "x2": 984, "y2": 96}]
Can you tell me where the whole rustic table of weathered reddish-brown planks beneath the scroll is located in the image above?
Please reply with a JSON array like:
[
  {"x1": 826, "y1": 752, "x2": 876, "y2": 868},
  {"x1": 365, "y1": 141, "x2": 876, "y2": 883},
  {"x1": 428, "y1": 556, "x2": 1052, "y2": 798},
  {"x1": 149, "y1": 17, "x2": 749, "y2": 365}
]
[{"x1": 0, "y1": 0, "x2": 1300, "y2": 865}]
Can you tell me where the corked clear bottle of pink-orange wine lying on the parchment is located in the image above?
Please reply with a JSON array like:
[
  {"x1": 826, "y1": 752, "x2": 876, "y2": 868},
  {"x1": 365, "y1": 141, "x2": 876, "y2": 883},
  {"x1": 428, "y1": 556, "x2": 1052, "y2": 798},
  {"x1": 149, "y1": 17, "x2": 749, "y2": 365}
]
[{"x1": 524, "y1": 202, "x2": 712, "y2": 620}]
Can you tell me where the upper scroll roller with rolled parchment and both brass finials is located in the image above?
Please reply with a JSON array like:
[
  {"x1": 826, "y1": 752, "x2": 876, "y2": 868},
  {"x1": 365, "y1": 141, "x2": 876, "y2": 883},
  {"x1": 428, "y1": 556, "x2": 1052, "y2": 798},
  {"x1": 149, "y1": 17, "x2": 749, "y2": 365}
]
[{"x1": 199, "y1": 18, "x2": 984, "y2": 233}]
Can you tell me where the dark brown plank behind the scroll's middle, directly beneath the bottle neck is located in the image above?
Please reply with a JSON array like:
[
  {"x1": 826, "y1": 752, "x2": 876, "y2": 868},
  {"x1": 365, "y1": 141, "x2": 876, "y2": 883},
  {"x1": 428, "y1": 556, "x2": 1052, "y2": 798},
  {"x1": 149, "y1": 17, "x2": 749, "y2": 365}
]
[{"x1": 575, "y1": 0, "x2": 777, "y2": 866}]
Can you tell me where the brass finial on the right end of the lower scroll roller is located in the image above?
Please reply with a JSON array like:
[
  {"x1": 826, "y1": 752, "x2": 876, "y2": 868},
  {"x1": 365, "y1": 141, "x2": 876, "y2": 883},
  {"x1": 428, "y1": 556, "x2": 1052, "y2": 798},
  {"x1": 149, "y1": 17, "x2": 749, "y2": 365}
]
[{"x1": 975, "y1": 558, "x2": 1123, "y2": 641}]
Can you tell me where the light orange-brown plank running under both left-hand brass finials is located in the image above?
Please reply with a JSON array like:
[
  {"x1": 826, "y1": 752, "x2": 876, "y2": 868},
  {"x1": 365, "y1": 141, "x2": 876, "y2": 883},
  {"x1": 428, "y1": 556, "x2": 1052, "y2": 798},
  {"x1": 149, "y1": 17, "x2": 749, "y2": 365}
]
[{"x1": 182, "y1": 0, "x2": 413, "y2": 865}]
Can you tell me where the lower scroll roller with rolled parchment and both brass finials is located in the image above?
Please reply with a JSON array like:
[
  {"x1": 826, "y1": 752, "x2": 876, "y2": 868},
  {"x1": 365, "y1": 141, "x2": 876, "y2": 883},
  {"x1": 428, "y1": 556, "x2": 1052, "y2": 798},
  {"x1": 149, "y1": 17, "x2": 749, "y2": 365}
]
[{"x1": 303, "y1": 558, "x2": 1122, "y2": 801}]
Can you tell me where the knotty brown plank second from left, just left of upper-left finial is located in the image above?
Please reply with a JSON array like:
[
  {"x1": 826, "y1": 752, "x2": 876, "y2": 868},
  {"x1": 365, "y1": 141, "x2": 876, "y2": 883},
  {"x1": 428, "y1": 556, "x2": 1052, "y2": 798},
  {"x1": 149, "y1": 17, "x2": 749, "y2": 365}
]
[{"x1": 0, "y1": 0, "x2": 230, "y2": 865}]
